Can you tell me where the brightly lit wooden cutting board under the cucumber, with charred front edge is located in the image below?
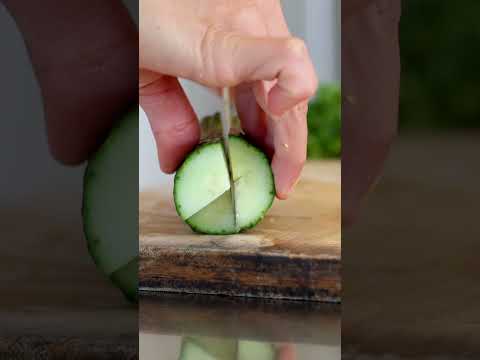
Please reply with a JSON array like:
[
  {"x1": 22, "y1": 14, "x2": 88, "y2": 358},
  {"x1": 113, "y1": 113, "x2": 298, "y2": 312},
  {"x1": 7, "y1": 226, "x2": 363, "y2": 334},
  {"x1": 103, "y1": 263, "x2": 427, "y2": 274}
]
[{"x1": 139, "y1": 161, "x2": 341, "y2": 302}]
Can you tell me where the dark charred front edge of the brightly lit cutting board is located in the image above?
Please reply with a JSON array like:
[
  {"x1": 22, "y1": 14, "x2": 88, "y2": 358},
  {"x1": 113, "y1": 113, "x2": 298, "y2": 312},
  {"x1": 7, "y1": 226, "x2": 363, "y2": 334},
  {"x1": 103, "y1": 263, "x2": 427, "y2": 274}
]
[{"x1": 139, "y1": 246, "x2": 341, "y2": 303}]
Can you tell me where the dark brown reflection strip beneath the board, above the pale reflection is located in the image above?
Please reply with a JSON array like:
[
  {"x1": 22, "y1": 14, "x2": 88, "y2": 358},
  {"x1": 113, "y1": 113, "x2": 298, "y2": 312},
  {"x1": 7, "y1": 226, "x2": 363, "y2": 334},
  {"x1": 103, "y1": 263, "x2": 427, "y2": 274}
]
[{"x1": 139, "y1": 293, "x2": 341, "y2": 346}]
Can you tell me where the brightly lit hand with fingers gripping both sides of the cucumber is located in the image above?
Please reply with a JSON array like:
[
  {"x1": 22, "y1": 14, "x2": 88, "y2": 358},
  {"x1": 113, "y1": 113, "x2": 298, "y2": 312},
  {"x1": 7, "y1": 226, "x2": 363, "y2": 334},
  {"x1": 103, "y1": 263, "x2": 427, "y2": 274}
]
[{"x1": 139, "y1": 0, "x2": 317, "y2": 199}]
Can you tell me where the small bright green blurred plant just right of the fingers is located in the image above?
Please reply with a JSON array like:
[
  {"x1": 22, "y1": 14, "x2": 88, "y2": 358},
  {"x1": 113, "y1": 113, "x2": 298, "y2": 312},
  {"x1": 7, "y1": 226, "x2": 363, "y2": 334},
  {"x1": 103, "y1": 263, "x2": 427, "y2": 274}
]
[{"x1": 307, "y1": 84, "x2": 342, "y2": 159}]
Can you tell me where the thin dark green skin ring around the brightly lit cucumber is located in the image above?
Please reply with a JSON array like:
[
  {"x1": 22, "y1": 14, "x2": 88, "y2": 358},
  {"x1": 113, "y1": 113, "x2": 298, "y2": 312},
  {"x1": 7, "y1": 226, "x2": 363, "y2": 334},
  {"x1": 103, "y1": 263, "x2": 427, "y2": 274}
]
[{"x1": 173, "y1": 135, "x2": 276, "y2": 235}]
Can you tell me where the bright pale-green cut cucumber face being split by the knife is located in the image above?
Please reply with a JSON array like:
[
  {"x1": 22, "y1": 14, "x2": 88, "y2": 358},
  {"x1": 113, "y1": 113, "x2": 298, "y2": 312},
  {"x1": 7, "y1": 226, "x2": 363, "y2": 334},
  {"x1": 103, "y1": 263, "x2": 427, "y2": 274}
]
[{"x1": 173, "y1": 136, "x2": 275, "y2": 235}]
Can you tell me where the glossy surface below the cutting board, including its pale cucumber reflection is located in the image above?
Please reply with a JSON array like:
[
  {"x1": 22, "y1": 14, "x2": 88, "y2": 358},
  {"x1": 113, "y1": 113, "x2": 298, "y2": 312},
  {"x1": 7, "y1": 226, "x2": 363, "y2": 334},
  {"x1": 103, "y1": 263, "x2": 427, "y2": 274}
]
[{"x1": 140, "y1": 293, "x2": 340, "y2": 360}]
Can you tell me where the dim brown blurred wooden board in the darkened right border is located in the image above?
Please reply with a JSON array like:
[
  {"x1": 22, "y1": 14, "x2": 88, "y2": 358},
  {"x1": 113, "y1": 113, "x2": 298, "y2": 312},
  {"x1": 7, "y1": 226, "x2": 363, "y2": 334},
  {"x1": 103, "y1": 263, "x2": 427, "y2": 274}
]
[{"x1": 342, "y1": 131, "x2": 480, "y2": 359}]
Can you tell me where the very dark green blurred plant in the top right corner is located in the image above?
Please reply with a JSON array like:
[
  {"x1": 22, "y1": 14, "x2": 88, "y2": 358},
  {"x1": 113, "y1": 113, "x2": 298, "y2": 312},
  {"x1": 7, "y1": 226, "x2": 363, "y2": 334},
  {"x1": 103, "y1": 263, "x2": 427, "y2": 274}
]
[{"x1": 400, "y1": 0, "x2": 480, "y2": 129}]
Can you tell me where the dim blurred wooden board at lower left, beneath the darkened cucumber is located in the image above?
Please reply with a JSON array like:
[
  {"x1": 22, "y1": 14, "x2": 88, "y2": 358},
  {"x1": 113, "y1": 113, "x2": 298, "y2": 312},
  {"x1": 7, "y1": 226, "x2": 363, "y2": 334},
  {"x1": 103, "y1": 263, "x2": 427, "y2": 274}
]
[{"x1": 0, "y1": 205, "x2": 138, "y2": 359}]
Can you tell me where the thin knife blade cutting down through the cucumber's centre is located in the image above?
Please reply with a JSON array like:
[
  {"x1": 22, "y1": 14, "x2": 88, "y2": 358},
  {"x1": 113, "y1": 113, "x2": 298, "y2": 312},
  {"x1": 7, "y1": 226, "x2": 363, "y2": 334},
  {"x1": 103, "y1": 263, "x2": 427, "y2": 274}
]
[{"x1": 221, "y1": 87, "x2": 238, "y2": 229}]
